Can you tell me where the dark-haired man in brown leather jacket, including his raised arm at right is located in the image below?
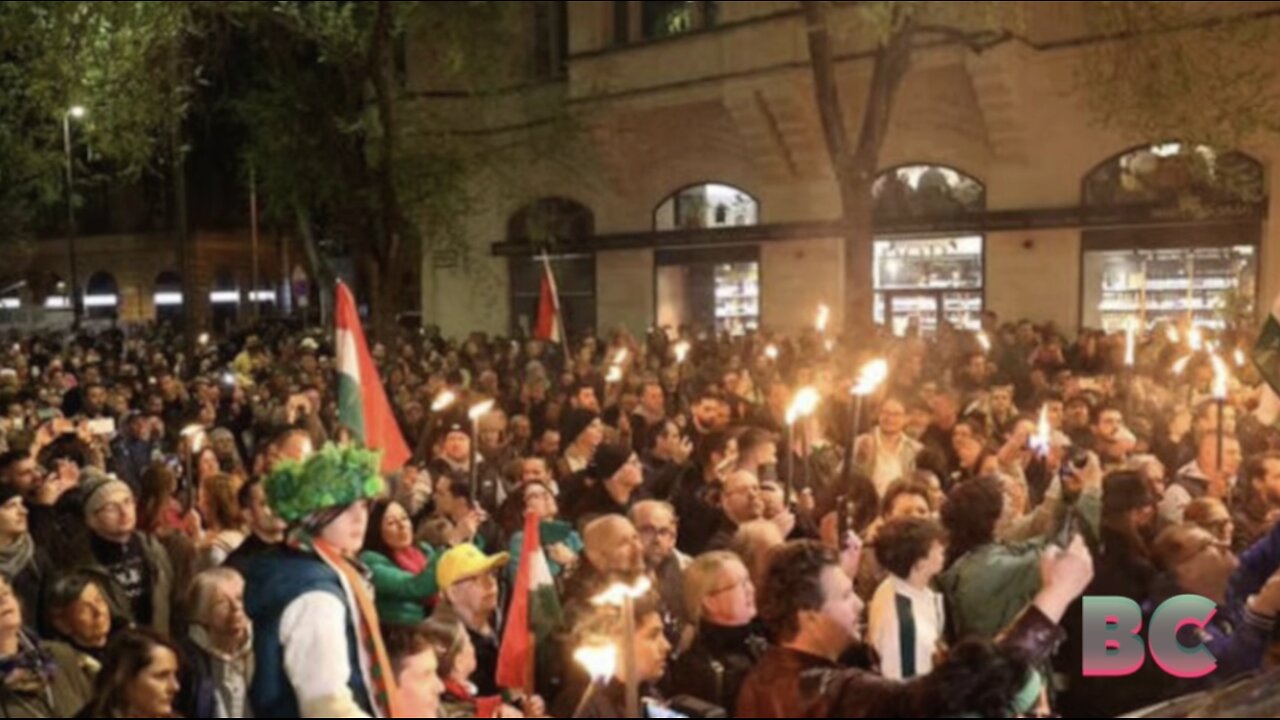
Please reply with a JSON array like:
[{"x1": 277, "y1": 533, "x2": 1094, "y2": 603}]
[{"x1": 737, "y1": 539, "x2": 1093, "y2": 717}]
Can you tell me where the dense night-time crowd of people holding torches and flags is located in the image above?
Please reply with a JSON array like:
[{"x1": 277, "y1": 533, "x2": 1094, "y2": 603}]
[{"x1": 0, "y1": 314, "x2": 1280, "y2": 717}]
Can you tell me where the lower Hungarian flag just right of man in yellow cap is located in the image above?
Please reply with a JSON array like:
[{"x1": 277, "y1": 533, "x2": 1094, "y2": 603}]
[{"x1": 497, "y1": 512, "x2": 561, "y2": 694}]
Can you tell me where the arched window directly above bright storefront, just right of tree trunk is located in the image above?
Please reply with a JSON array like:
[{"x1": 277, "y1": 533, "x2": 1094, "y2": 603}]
[{"x1": 872, "y1": 165, "x2": 987, "y2": 223}]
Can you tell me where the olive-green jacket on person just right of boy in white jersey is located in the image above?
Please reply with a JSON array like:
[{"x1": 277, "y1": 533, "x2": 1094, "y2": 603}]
[{"x1": 937, "y1": 541, "x2": 1047, "y2": 639}]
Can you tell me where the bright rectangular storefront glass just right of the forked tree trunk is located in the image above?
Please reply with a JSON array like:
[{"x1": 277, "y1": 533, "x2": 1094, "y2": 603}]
[{"x1": 876, "y1": 236, "x2": 984, "y2": 336}]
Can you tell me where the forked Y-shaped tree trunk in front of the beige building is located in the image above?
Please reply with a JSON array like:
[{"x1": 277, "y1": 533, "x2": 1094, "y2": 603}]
[{"x1": 801, "y1": 1, "x2": 915, "y2": 334}]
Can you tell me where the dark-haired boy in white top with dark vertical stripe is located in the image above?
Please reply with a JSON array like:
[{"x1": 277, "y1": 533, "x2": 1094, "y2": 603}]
[{"x1": 867, "y1": 518, "x2": 946, "y2": 680}]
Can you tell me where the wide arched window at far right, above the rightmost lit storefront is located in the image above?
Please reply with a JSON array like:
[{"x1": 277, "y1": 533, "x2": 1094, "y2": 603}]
[{"x1": 1083, "y1": 142, "x2": 1266, "y2": 217}]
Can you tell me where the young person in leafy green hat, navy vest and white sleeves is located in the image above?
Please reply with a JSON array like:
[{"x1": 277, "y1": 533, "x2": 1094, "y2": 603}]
[{"x1": 244, "y1": 445, "x2": 399, "y2": 717}]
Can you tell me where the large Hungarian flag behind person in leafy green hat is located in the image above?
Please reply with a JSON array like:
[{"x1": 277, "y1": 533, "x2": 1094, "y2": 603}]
[{"x1": 334, "y1": 282, "x2": 412, "y2": 473}]
